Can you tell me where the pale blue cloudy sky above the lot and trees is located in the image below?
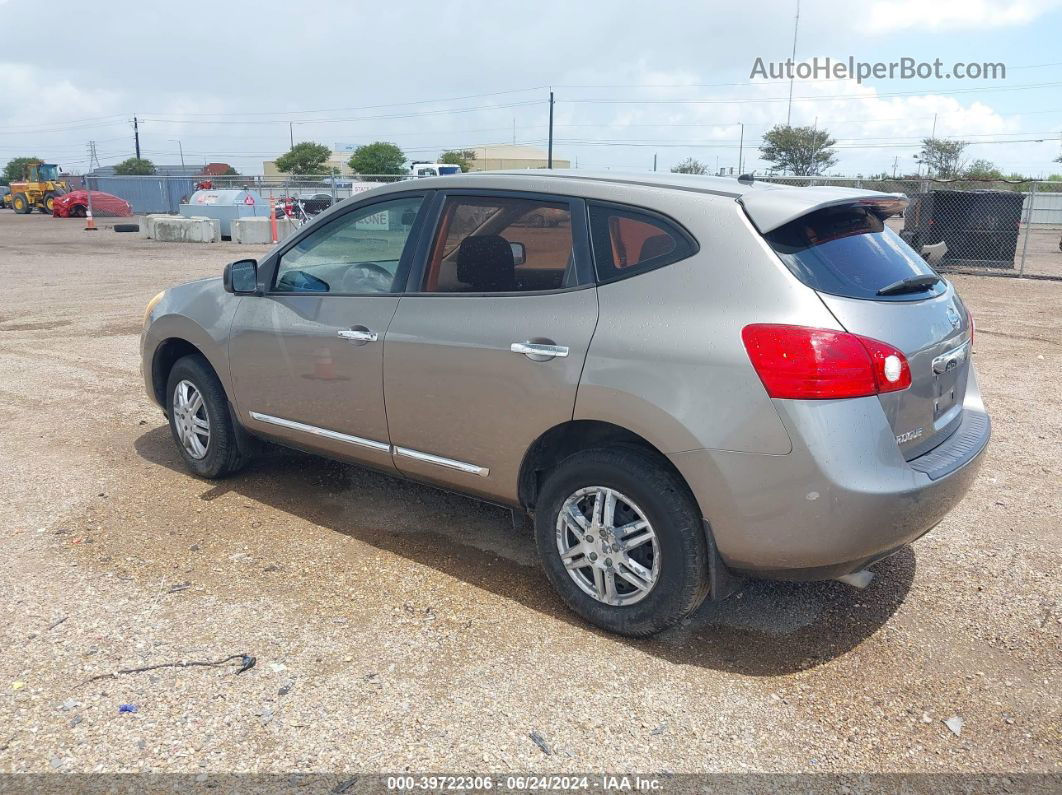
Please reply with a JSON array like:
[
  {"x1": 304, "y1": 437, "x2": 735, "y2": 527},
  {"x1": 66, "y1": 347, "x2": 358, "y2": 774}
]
[{"x1": 0, "y1": 0, "x2": 1062, "y2": 175}]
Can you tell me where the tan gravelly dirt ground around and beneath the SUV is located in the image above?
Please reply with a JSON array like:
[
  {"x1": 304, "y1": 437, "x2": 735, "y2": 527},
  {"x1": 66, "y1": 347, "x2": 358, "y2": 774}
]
[{"x1": 0, "y1": 212, "x2": 1062, "y2": 773}]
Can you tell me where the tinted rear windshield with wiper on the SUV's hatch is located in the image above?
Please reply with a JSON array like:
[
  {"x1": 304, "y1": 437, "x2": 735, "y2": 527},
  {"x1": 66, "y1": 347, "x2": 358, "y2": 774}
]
[{"x1": 764, "y1": 207, "x2": 947, "y2": 301}]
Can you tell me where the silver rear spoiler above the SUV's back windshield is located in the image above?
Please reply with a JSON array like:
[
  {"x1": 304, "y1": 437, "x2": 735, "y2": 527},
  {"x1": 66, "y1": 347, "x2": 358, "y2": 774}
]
[{"x1": 737, "y1": 186, "x2": 908, "y2": 235}]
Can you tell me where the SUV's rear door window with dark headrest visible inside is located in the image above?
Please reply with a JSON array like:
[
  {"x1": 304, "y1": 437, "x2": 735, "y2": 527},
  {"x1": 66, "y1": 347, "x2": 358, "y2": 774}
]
[{"x1": 422, "y1": 196, "x2": 576, "y2": 293}]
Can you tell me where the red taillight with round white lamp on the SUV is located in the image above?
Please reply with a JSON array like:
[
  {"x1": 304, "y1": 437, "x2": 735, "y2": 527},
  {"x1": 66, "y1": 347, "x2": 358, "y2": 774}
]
[{"x1": 741, "y1": 323, "x2": 911, "y2": 400}]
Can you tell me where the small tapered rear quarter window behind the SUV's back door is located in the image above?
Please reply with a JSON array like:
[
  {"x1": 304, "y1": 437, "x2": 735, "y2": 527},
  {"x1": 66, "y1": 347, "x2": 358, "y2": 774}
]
[{"x1": 589, "y1": 205, "x2": 697, "y2": 281}]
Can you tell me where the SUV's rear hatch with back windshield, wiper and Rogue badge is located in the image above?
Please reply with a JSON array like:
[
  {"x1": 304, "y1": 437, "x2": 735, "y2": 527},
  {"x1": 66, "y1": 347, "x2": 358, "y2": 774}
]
[{"x1": 742, "y1": 189, "x2": 972, "y2": 461}]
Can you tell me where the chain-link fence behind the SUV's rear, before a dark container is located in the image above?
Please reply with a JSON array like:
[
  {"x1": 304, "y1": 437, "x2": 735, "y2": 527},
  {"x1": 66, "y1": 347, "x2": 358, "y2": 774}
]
[{"x1": 756, "y1": 176, "x2": 1062, "y2": 280}]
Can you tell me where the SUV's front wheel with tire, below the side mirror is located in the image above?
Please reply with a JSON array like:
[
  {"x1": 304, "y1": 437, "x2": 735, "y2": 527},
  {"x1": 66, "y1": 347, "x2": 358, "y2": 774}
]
[{"x1": 166, "y1": 356, "x2": 245, "y2": 479}]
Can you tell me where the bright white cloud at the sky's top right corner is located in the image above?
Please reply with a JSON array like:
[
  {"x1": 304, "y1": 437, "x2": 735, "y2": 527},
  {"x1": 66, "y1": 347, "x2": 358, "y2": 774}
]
[{"x1": 859, "y1": 0, "x2": 1062, "y2": 33}]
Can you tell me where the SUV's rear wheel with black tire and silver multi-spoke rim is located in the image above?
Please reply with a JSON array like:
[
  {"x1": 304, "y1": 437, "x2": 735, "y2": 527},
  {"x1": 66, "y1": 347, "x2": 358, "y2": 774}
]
[{"x1": 535, "y1": 448, "x2": 708, "y2": 637}]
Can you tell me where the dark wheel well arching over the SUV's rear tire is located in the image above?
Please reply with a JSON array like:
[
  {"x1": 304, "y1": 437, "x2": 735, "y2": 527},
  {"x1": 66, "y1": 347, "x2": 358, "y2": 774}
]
[{"x1": 517, "y1": 419, "x2": 703, "y2": 513}]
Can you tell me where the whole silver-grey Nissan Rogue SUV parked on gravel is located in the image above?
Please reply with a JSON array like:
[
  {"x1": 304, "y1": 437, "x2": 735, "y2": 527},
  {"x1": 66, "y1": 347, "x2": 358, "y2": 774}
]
[{"x1": 141, "y1": 171, "x2": 990, "y2": 636}]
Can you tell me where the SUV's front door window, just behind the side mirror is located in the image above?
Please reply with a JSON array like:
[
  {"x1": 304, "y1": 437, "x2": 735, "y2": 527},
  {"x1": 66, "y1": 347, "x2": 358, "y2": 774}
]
[{"x1": 274, "y1": 196, "x2": 423, "y2": 294}]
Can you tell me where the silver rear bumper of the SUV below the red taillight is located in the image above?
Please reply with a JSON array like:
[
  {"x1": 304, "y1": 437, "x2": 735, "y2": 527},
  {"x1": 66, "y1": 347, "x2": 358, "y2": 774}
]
[{"x1": 670, "y1": 370, "x2": 991, "y2": 580}]
